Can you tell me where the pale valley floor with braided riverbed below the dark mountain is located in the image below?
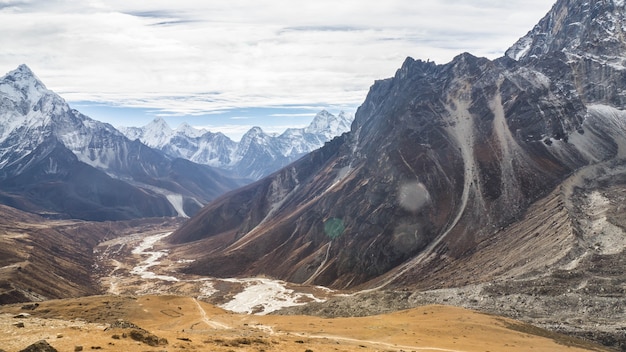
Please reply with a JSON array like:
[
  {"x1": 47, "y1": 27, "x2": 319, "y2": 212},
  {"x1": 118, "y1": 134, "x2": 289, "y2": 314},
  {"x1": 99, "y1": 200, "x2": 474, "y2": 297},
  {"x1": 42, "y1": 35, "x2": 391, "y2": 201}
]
[{"x1": 94, "y1": 230, "x2": 334, "y2": 314}]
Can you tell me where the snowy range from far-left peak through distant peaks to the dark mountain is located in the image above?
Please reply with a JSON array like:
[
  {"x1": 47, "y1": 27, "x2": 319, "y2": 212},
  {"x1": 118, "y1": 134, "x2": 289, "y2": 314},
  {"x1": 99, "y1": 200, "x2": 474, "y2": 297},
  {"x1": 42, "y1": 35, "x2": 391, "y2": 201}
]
[{"x1": 0, "y1": 65, "x2": 351, "y2": 221}]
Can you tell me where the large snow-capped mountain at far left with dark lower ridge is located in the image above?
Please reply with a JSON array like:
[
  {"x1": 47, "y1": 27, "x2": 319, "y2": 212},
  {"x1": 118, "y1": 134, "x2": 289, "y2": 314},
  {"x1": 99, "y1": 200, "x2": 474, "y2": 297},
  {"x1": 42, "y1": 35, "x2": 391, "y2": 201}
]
[{"x1": 0, "y1": 65, "x2": 242, "y2": 220}]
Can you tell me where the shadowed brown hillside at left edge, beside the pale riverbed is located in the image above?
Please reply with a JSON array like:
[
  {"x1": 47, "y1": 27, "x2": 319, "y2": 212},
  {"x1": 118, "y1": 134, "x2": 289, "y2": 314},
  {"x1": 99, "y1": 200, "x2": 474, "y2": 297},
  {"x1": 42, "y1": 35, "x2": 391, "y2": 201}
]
[{"x1": 0, "y1": 206, "x2": 185, "y2": 304}]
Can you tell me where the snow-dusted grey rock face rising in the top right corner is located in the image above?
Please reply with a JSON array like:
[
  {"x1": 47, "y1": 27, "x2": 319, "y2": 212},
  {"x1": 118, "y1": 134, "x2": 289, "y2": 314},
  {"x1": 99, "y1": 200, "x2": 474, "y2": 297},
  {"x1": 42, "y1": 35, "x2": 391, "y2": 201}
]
[{"x1": 506, "y1": 0, "x2": 626, "y2": 107}]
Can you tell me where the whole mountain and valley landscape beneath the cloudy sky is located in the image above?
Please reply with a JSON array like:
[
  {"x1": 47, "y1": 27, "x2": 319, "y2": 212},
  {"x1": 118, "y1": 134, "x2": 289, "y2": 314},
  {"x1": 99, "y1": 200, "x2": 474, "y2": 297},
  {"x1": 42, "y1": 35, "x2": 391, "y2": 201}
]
[{"x1": 0, "y1": 0, "x2": 626, "y2": 352}]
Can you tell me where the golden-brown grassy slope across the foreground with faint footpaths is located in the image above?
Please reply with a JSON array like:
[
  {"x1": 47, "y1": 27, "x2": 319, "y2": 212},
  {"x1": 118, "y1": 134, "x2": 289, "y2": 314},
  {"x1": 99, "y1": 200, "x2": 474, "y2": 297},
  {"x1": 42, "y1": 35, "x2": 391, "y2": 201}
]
[{"x1": 0, "y1": 296, "x2": 602, "y2": 352}]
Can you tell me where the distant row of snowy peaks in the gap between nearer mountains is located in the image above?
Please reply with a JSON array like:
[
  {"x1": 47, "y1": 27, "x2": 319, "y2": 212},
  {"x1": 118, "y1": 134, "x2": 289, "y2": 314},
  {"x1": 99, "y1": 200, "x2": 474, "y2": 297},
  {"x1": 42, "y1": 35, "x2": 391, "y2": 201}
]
[{"x1": 120, "y1": 110, "x2": 353, "y2": 180}]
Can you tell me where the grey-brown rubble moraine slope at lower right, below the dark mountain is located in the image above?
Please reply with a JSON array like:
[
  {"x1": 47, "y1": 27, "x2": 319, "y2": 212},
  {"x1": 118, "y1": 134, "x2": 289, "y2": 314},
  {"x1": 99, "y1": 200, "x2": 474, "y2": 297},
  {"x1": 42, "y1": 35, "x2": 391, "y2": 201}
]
[{"x1": 276, "y1": 165, "x2": 626, "y2": 351}]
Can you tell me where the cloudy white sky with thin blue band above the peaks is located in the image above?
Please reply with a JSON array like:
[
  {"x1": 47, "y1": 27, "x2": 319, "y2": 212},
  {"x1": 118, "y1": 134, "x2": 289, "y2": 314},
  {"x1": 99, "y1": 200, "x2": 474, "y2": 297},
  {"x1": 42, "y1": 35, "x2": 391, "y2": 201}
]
[{"x1": 0, "y1": 0, "x2": 554, "y2": 140}]
